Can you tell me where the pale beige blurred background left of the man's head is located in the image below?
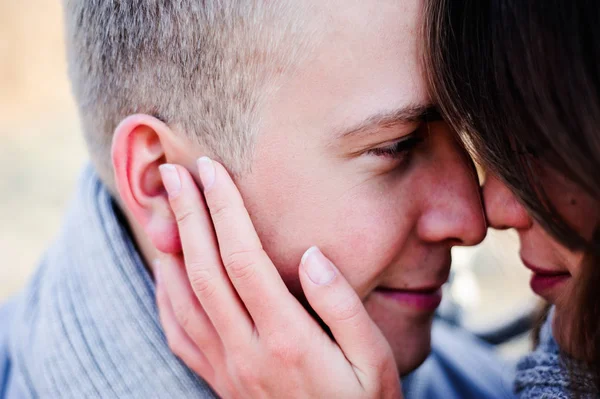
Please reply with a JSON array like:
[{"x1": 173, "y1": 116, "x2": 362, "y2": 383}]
[{"x1": 0, "y1": 0, "x2": 85, "y2": 301}]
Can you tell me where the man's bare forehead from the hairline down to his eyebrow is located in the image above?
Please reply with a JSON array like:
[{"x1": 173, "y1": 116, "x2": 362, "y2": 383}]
[{"x1": 263, "y1": 0, "x2": 426, "y2": 140}]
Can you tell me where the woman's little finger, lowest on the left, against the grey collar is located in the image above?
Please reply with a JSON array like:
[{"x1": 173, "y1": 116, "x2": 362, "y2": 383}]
[{"x1": 154, "y1": 258, "x2": 218, "y2": 380}]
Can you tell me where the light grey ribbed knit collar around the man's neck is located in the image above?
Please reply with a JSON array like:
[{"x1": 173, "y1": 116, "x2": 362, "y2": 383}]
[{"x1": 5, "y1": 167, "x2": 214, "y2": 399}]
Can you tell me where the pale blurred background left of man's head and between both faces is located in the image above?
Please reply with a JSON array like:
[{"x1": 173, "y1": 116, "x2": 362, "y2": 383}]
[{"x1": 0, "y1": 0, "x2": 532, "y2": 360}]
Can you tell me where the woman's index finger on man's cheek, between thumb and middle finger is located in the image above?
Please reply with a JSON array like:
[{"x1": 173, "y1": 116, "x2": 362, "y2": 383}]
[{"x1": 198, "y1": 157, "x2": 310, "y2": 332}]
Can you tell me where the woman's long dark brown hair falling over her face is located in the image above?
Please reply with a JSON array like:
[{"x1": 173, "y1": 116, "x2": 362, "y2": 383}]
[{"x1": 424, "y1": 0, "x2": 600, "y2": 387}]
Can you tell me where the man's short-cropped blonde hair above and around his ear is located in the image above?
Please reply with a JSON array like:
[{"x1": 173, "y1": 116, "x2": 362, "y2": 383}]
[{"x1": 65, "y1": 0, "x2": 313, "y2": 185}]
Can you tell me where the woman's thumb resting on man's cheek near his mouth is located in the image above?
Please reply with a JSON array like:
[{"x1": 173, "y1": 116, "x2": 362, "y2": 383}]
[{"x1": 300, "y1": 247, "x2": 398, "y2": 390}]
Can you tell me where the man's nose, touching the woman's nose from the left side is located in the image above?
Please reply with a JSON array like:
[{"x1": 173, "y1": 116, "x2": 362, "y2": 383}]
[{"x1": 418, "y1": 165, "x2": 487, "y2": 246}]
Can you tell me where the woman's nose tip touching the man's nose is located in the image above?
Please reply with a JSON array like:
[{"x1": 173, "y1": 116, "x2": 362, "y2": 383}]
[{"x1": 483, "y1": 174, "x2": 531, "y2": 230}]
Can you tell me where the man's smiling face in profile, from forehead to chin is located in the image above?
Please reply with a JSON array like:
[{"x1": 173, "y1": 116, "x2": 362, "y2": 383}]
[{"x1": 183, "y1": 0, "x2": 485, "y2": 373}]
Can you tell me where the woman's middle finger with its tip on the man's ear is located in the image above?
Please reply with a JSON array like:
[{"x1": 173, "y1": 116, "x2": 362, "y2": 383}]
[{"x1": 160, "y1": 164, "x2": 254, "y2": 343}]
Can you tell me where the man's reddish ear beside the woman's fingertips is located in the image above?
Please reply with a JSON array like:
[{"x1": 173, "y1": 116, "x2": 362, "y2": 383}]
[{"x1": 112, "y1": 115, "x2": 181, "y2": 253}]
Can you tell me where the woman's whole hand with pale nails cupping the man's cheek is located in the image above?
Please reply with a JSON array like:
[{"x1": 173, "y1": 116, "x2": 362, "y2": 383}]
[{"x1": 156, "y1": 158, "x2": 402, "y2": 398}]
